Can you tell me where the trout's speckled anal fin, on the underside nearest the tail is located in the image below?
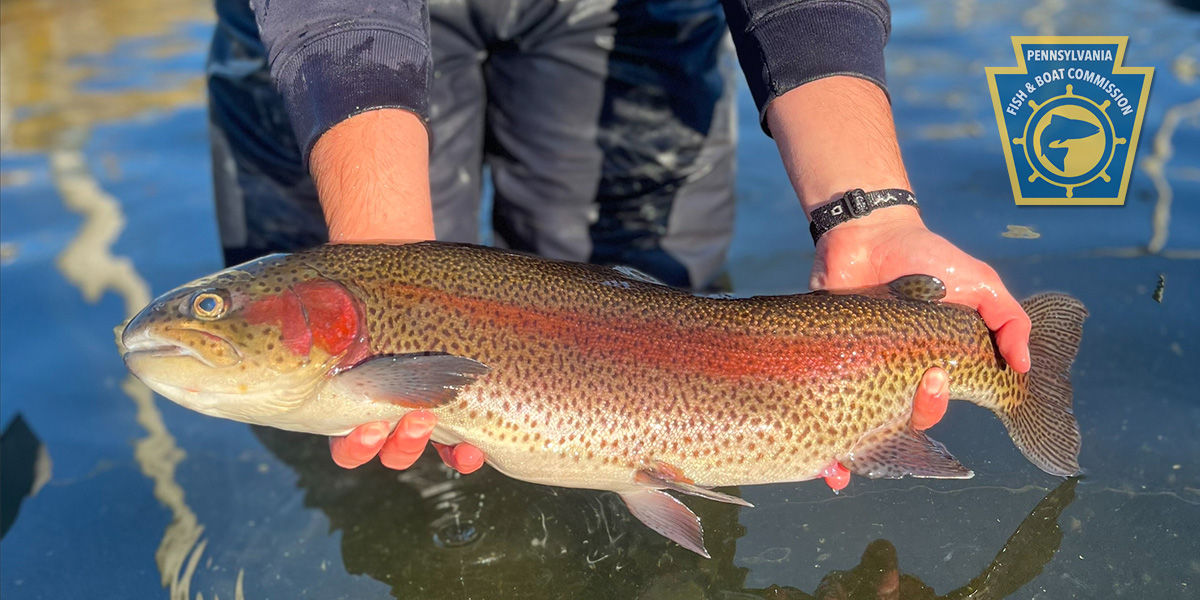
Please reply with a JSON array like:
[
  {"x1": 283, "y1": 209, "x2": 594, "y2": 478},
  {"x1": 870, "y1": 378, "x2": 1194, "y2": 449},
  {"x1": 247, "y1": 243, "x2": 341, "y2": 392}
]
[{"x1": 842, "y1": 422, "x2": 974, "y2": 479}]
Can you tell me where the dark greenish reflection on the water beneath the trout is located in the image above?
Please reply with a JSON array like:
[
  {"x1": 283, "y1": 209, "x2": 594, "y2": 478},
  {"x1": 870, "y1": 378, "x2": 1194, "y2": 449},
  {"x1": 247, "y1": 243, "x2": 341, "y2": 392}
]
[{"x1": 254, "y1": 427, "x2": 1076, "y2": 600}]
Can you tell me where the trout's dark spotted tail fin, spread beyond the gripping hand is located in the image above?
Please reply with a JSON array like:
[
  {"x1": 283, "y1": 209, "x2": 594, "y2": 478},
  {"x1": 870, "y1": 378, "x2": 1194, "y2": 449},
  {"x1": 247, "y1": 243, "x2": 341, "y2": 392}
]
[{"x1": 997, "y1": 293, "x2": 1087, "y2": 476}]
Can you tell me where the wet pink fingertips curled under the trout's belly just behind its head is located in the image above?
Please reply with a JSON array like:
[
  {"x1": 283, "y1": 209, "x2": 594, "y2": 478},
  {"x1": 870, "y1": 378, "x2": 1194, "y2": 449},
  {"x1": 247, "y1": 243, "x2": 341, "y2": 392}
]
[{"x1": 329, "y1": 410, "x2": 484, "y2": 475}]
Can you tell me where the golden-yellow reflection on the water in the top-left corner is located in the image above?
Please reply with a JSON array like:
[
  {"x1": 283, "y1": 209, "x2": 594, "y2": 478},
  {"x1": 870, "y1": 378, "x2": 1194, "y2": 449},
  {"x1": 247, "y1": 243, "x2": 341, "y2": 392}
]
[{"x1": 0, "y1": 0, "x2": 212, "y2": 151}]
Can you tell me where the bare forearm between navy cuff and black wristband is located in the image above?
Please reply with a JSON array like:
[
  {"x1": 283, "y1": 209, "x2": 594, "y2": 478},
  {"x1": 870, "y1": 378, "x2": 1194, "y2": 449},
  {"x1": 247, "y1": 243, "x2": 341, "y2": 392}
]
[{"x1": 766, "y1": 76, "x2": 914, "y2": 214}]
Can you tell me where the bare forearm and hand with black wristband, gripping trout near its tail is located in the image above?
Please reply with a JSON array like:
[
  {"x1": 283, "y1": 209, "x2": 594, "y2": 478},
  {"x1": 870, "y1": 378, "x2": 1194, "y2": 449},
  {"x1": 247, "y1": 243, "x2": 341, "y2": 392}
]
[{"x1": 767, "y1": 76, "x2": 1030, "y2": 373}]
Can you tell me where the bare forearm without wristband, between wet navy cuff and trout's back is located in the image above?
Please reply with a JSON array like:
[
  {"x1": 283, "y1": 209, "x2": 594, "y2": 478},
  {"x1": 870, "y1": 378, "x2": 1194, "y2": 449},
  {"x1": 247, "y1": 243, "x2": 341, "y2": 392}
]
[{"x1": 308, "y1": 108, "x2": 433, "y2": 242}]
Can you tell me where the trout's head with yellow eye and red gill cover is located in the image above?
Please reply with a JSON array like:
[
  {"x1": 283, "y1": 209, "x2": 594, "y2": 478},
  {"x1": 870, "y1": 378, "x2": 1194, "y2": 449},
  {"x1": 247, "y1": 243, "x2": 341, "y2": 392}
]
[{"x1": 119, "y1": 254, "x2": 370, "y2": 425}]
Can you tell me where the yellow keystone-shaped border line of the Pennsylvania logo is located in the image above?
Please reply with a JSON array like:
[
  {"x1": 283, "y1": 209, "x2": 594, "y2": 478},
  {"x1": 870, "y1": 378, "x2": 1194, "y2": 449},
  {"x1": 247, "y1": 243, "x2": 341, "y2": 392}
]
[{"x1": 984, "y1": 36, "x2": 1154, "y2": 206}]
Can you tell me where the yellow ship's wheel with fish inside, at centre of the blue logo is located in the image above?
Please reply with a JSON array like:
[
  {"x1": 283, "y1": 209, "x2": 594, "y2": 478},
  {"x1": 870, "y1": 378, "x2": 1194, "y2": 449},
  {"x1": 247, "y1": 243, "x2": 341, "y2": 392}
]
[{"x1": 1013, "y1": 85, "x2": 1127, "y2": 198}]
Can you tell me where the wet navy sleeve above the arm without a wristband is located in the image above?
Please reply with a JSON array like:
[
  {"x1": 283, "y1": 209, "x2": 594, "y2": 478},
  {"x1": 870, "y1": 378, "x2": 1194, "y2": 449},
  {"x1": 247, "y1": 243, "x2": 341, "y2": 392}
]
[{"x1": 251, "y1": 0, "x2": 433, "y2": 166}]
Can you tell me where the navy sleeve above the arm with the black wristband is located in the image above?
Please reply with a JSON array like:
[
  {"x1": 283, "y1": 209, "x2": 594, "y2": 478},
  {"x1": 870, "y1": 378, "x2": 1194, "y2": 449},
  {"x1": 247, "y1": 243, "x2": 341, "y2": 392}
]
[{"x1": 722, "y1": 0, "x2": 892, "y2": 136}]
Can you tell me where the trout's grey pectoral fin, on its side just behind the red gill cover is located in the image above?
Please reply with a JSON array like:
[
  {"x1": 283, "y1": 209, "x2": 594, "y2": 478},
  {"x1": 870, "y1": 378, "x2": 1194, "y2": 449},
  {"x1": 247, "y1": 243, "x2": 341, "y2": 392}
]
[{"x1": 331, "y1": 354, "x2": 490, "y2": 408}]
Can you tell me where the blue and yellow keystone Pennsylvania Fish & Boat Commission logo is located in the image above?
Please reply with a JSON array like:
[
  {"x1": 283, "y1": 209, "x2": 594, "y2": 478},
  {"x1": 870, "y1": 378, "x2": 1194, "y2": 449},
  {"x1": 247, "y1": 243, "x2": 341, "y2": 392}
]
[{"x1": 986, "y1": 36, "x2": 1154, "y2": 205}]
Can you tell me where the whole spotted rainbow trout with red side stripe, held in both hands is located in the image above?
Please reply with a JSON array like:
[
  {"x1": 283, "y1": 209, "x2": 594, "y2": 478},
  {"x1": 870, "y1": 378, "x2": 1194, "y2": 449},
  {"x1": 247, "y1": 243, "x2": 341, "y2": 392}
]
[{"x1": 118, "y1": 241, "x2": 1087, "y2": 557}]
